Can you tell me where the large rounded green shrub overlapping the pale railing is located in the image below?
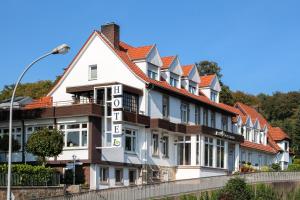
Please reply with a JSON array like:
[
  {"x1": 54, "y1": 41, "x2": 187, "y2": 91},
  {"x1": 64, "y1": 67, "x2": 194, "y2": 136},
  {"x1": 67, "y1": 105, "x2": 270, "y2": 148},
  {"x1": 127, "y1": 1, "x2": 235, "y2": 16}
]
[{"x1": 218, "y1": 177, "x2": 253, "y2": 200}]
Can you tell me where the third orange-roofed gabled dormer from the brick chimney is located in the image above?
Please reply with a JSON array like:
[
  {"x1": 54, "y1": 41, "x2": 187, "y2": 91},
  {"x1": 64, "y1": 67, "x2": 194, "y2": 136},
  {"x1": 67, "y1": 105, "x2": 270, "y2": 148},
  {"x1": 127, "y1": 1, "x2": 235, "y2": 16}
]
[{"x1": 181, "y1": 64, "x2": 200, "y2": 95}]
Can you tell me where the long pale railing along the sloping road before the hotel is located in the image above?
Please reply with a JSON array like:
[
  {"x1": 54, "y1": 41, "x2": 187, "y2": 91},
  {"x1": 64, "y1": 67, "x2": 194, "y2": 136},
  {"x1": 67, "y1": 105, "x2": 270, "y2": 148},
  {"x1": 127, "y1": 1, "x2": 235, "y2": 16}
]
[{"x1": 38, "y1": 172, "x2": 300, "y2": 200}]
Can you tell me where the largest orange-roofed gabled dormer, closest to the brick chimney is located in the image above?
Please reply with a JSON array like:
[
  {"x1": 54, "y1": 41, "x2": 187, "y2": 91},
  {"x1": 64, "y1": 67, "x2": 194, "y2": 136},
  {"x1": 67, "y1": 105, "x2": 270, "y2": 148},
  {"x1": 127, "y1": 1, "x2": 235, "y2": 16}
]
[{"x1": 127, "y1": 45, "x2": 163, "y2": 81}]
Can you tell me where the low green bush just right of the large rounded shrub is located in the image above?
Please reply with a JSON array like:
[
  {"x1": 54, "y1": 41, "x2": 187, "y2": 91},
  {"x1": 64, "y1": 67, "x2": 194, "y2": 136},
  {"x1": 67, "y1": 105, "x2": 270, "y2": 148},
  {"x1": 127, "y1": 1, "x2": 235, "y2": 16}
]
[{"x1": 254, "y1": 184, "x2": 280, "y2": 200}]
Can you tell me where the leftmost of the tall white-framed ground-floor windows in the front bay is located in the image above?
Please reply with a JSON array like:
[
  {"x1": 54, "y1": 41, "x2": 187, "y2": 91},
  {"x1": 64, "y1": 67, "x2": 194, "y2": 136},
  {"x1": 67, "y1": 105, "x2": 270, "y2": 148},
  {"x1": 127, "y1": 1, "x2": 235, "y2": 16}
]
[{"x1": 177, "y1": 136, "x2": 191, "y2": 165}]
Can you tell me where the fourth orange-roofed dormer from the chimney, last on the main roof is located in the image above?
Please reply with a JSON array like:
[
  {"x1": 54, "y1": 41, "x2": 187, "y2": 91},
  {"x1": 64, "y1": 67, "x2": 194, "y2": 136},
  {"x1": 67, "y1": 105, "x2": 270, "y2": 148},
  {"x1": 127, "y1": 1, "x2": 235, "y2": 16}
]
[{"x1": 199, "y1": 74, "x2": 221, "y2": 103}]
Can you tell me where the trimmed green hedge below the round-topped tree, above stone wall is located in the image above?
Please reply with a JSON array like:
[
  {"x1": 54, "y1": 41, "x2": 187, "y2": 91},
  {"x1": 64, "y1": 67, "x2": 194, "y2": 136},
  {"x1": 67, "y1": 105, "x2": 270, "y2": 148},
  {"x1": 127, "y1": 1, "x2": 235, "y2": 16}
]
[{"x1": 0, "y1": 164, "x2": 57, "y2": 185}]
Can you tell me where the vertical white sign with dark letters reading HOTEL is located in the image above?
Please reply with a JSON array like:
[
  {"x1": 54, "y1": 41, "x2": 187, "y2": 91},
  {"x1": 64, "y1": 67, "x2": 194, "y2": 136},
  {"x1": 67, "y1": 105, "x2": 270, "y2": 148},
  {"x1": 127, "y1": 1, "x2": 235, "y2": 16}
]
[{"x1": 112, "y1": 85, "x2": 123, "y2": 147}]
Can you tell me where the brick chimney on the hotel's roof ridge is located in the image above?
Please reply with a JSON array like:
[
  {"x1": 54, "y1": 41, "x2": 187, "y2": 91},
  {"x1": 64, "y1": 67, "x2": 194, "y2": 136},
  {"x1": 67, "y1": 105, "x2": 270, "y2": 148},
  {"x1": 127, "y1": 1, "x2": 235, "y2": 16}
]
[{"x1": 101, "y1": 22, "x2": 120, "y2": 49}]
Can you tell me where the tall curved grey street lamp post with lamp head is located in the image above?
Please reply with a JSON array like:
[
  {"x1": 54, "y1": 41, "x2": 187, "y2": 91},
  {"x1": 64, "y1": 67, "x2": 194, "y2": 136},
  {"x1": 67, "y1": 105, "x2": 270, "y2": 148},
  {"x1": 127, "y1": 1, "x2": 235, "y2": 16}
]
[{"x1": 7, "y1": 44, "x2": 70, "y2": 200}]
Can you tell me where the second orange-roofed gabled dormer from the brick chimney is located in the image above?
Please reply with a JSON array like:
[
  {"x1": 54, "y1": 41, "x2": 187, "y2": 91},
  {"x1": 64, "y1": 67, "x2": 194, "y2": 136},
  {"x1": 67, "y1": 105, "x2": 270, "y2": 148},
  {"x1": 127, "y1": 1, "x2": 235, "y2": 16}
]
[{"x1": 161, "y1": 56, "x2": 183, "y2": 88}]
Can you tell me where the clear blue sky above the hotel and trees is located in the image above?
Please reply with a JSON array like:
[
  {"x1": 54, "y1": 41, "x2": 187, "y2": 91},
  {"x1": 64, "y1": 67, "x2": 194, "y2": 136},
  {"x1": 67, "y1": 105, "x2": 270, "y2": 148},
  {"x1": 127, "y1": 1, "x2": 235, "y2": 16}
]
[{"x1": 0, "y1": 0, "x2": 300, "y2": 94}]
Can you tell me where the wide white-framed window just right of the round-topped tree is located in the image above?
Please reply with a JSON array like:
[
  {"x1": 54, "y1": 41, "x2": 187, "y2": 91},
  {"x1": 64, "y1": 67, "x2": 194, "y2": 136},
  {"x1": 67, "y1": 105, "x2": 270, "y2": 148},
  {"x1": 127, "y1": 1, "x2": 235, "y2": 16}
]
[{"x1": 59, "y1": 123, "x2": 88, "y2": 148}]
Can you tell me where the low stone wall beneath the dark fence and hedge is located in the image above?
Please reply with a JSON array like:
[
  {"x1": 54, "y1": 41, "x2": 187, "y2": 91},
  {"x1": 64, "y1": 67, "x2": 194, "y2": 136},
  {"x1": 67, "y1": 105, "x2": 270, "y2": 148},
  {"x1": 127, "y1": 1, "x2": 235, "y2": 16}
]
[{"x1": 0, "y1": 186, "x2": 65, "y2": 200}]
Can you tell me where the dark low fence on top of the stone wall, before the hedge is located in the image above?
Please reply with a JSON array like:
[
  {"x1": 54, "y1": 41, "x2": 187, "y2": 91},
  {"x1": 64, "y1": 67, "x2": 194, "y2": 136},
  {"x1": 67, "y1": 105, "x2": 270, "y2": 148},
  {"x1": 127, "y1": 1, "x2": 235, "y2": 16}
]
[{"x1": 0, "y1": 173, "x2": 60, "y2": 186}]
